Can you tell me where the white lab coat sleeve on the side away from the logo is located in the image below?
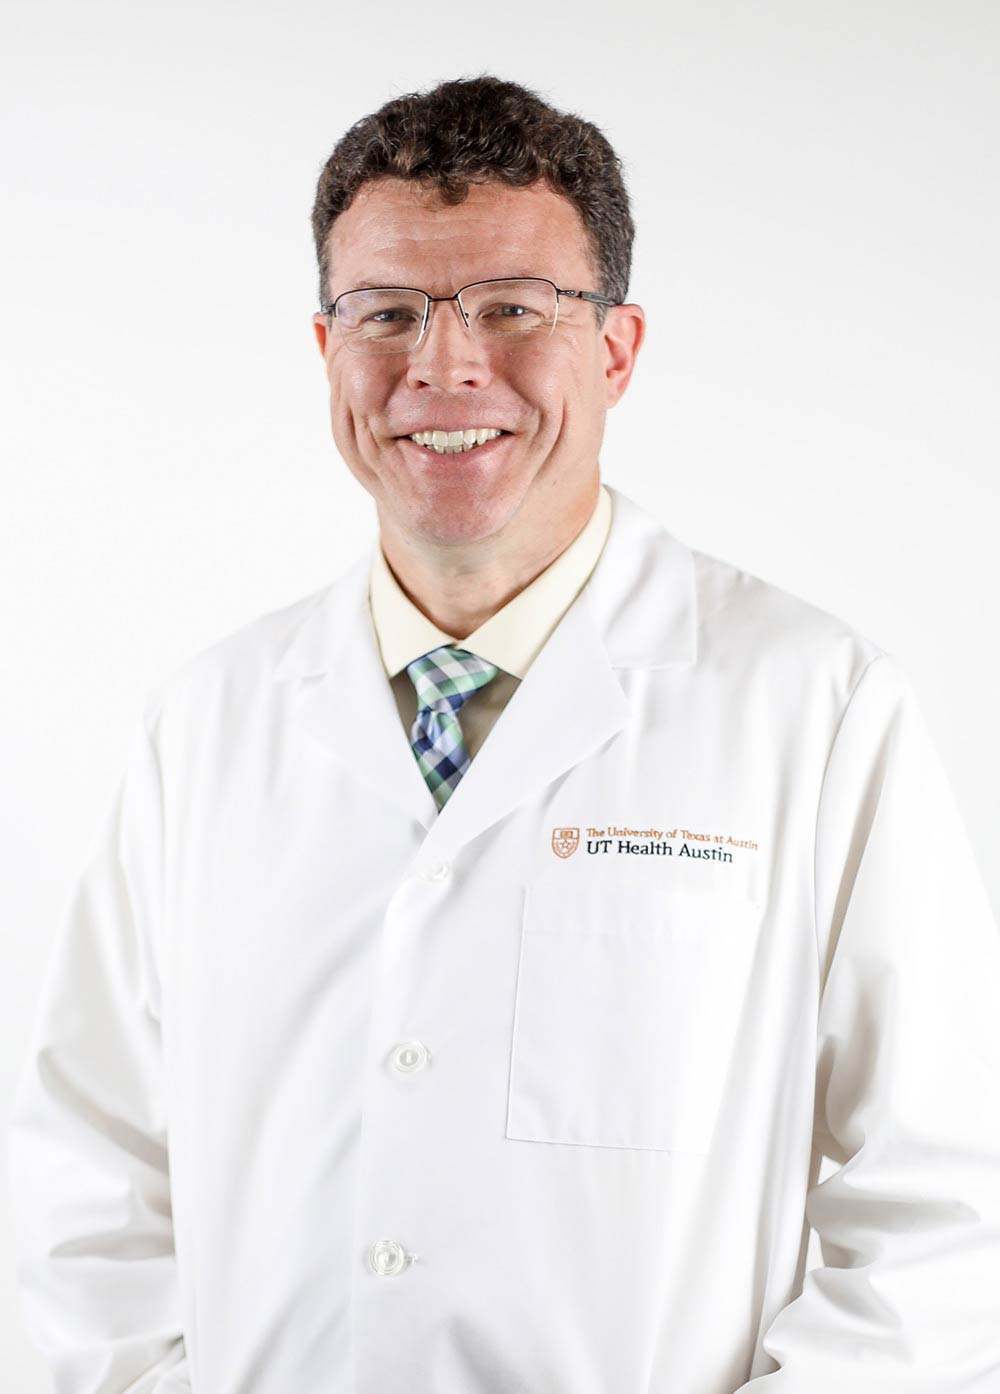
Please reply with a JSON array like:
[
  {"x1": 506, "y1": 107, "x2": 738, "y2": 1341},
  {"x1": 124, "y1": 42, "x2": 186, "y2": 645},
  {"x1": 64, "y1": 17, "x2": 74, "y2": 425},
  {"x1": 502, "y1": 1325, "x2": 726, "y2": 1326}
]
[{"x1": 7, "y1": 704, "x2": 191, "y2": 1394}]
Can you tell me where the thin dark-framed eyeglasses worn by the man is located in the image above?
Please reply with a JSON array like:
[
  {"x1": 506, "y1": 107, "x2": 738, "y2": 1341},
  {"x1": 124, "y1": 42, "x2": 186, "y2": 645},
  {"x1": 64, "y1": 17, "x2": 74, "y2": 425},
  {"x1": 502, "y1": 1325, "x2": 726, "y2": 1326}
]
[{"x1": 322, "y1": 276, "x2": 621, "y2": 354}]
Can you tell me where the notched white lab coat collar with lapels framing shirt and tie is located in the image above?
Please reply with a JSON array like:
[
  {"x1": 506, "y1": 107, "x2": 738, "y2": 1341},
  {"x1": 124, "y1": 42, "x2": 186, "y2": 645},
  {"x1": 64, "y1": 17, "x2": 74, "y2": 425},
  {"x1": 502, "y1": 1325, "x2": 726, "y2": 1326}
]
[{"x1": 273, "y1": 485, "x2": 697, "y2": 859}]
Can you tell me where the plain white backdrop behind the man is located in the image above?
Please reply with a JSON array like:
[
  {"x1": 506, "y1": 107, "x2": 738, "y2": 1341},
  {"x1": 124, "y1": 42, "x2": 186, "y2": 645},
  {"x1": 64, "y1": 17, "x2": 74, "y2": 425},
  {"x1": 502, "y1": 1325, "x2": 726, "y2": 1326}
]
[{"x1": 0, "y1": 0, "x2": 1000, "y2": 1394}]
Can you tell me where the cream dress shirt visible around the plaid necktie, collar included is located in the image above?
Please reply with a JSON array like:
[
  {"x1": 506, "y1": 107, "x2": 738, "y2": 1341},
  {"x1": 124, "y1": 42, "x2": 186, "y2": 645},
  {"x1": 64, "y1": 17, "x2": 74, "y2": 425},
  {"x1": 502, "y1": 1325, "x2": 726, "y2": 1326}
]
[{"x1": 368, "y1": 485, "x2": 611, "y2": 758}]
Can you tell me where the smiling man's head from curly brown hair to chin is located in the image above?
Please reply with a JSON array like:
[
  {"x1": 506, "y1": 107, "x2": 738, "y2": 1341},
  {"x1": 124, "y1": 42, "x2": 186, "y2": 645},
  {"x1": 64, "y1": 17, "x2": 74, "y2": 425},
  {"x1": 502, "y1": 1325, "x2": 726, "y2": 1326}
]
[{"x1": 312, "y1": 77, "x2": 644, "y2": 553}]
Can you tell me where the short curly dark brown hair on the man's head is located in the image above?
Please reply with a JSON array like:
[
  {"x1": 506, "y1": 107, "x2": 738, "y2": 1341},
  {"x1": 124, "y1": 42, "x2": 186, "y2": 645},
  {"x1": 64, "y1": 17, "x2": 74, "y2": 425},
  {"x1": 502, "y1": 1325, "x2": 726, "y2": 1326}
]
[{"x1": 312, "y1": 72, "x2": 635, "y2": 325}]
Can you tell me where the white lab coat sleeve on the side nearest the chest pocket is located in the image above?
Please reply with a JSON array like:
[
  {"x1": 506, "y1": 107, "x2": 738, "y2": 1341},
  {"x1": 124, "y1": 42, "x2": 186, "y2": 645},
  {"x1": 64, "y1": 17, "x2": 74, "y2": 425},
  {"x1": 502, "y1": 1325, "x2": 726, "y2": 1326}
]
[{"x1": 736, "y1": 652, "x2": 1000, "y2": 1394}]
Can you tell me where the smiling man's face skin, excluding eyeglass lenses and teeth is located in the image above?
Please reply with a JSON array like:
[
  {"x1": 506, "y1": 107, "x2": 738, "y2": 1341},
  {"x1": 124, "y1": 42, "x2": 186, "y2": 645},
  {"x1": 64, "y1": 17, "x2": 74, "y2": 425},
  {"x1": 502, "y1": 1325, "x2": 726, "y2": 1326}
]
[{"x1": 314, "y1": 177, "x2": 643, "y2": 546}]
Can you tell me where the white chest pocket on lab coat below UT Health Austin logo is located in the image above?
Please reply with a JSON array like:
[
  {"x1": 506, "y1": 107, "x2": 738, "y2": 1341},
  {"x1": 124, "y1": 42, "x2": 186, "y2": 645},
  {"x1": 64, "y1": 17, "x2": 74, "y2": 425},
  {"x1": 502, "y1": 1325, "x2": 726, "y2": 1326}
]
[{"x1": 506, "y1": 873, "x2": 762, "y2": 1153}]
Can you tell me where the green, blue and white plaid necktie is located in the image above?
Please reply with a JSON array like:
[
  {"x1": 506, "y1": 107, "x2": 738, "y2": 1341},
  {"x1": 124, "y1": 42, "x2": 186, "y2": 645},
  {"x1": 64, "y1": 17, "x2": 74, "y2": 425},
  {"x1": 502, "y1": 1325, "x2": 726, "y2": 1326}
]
[{"x1": 406, "y1": 644, "x2": 499, "y2": 809}]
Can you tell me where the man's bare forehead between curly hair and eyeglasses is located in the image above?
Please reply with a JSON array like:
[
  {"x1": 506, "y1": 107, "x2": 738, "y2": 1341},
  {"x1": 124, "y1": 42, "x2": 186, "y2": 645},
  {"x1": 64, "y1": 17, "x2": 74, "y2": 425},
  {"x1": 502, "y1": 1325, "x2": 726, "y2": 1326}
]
[{"x1": 328, "y1": 177, "x2": 593, "y2": 294}]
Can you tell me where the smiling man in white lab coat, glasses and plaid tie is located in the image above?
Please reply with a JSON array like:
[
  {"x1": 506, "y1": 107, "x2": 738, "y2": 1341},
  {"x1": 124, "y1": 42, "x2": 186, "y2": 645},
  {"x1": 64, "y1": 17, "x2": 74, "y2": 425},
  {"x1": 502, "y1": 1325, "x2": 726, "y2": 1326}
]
[{"x1": 10, "y1": 77, "x2": 1000, "y2": 1394}]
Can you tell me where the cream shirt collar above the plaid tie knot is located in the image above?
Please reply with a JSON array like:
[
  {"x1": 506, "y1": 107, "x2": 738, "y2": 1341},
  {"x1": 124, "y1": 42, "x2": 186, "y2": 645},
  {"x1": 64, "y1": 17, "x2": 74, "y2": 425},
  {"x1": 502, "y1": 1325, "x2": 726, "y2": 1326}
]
[{"x1": 368, "y1": 484, "x2": 611, "y2": 677}]
